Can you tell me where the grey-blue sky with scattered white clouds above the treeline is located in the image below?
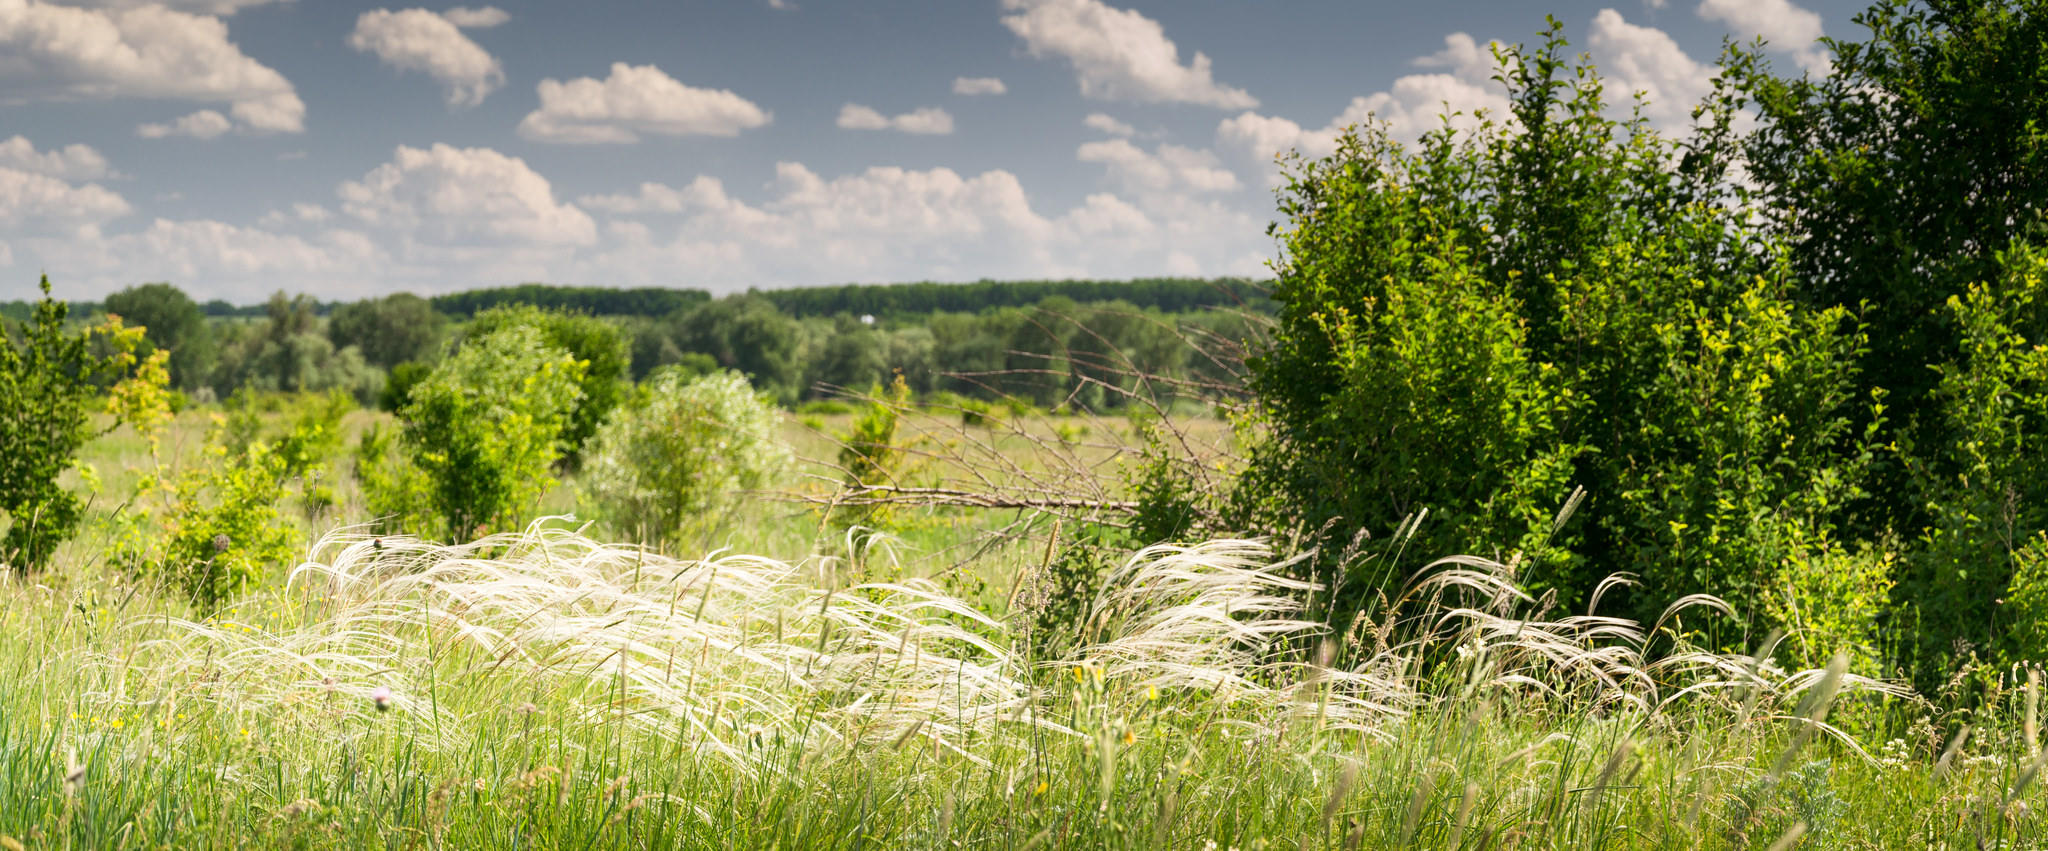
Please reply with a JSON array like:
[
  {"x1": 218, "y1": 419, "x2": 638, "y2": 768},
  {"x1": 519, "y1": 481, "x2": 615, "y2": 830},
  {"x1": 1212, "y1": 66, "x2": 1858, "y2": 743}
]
[{"x1": 0, "y1": 0, "x2": 1864, "y2": 303}]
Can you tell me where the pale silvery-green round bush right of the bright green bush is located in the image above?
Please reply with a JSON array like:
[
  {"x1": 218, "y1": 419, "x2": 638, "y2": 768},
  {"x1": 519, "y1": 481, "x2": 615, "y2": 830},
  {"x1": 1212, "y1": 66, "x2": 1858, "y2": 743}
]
[{"x1": 580, "y1": 370, "x2": 791, "y2": 544}]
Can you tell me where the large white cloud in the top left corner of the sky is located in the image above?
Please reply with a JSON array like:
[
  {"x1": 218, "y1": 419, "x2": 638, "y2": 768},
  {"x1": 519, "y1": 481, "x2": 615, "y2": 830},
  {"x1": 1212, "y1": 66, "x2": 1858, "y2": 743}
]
[{"x1": 0, "y1": 0, "x2": 305, "y2": 133}]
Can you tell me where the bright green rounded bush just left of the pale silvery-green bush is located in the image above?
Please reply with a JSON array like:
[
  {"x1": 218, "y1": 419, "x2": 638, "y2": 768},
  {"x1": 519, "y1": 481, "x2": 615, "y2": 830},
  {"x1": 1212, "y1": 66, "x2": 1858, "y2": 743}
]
[{"x1": 356, "y1": 323, "x2": 584, "y2": 540}]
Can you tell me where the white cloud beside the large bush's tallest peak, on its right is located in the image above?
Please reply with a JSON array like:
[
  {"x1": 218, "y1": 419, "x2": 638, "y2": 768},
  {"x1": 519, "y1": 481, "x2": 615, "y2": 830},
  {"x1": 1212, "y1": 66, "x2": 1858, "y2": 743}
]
[{"x1": 1585, "y1": 8, "x2": 1714, "y2": 133}]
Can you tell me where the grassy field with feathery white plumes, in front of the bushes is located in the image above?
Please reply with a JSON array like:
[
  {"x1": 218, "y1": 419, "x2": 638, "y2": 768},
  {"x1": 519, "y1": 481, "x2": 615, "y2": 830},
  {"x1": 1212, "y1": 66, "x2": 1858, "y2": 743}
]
[{"x1": 0, "y1": 402, "x2": 2048, "y2": 851}]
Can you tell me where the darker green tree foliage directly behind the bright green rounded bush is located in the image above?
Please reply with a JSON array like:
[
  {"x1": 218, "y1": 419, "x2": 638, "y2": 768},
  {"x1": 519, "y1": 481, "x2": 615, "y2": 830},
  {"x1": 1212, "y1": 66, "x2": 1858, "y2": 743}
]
[{"x1": 463, "y1": 305, "x2": 633, "y2": 466}]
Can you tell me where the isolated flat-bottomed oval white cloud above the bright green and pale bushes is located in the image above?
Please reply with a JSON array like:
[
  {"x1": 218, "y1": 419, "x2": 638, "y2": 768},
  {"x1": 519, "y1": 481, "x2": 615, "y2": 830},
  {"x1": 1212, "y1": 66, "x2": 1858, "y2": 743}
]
[{"x1": 518, "y1": 61, "x2": 772, "y2": 143}]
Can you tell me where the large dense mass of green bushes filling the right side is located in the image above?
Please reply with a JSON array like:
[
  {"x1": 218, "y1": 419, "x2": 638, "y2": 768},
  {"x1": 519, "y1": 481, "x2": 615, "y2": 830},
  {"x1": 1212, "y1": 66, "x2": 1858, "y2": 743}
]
[{"x1": 1233, "y1": 11, "x2": 2048, "y2": 675}]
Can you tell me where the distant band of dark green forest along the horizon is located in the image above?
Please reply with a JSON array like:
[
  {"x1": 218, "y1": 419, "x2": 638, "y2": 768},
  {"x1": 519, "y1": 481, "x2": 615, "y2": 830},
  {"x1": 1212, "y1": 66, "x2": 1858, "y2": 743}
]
[{"x1": 0, "y1": 278, "x2": 1274, "y2": 409}]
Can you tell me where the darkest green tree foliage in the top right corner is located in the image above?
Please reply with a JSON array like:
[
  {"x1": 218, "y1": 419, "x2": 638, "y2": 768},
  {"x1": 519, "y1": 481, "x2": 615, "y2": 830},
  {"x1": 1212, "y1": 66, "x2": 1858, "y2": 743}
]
[{"x1": 1726, "y1": 0, "x2": 2048, "y2": 452}]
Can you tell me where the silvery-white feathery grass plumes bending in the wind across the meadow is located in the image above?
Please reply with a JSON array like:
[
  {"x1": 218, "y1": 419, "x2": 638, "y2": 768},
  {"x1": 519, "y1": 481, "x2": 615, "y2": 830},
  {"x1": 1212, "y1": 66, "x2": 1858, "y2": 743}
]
[{"x1": 80, "y1": 522, "x2": 1896, "y2": 773}]
